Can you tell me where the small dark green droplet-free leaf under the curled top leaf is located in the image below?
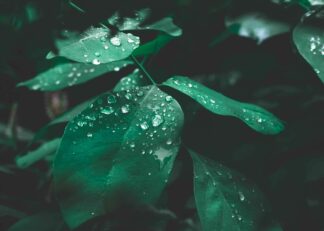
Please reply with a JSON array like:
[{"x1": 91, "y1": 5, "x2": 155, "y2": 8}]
[{"x1": 133, "y1": 33, "x2": 173, "y2": 56}]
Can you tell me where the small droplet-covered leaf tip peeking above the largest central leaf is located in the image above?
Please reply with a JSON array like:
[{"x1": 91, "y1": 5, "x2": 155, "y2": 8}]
[{"x1": 114, "y1": 68, "x2": 147, "y2": 92}]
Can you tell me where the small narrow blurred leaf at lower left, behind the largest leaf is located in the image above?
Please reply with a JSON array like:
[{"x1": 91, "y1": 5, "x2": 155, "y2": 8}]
[{"x1": 16, "y1": 139, "x2": 61, "y2": 168}]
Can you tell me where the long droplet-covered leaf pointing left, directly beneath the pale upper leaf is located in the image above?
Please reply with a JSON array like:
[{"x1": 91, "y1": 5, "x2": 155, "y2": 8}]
[{"x1": 18, "y1": 60, "x2": 132, "y2": 91}]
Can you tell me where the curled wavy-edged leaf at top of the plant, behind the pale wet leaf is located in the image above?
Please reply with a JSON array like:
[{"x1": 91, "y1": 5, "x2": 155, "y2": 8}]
[{"x1": 108, "y1": 9, "x2": 182, "y2": 37}]
